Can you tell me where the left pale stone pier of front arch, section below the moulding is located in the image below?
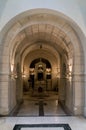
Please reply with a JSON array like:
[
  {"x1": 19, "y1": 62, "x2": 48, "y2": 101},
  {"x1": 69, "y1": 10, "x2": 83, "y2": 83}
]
[{"x1": 0, "y1": 74, "x2": 9, "y2": 115}]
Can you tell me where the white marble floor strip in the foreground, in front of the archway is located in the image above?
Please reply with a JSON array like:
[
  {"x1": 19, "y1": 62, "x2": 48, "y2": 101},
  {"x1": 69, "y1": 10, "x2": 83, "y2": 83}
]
[{"x1": 0, "y1": 116, "x2": 86, "y2": 130}]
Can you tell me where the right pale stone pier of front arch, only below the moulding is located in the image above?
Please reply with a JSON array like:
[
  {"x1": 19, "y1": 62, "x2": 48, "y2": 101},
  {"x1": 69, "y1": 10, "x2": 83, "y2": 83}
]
[{"x1": 73, "y1": 74, "x2": 84, "y2": 115}]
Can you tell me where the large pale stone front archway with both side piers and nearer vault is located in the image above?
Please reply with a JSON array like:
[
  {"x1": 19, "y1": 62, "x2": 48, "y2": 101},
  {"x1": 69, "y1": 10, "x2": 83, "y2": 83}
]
[{"x1": 0, "y1": 9, "x2": 84, "y2": 115}]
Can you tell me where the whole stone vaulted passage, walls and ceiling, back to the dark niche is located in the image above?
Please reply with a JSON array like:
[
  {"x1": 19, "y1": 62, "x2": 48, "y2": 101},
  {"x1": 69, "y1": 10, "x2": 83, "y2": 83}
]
[{"x1": 1, "y1": 9, "x2": 84, "y2": 115}]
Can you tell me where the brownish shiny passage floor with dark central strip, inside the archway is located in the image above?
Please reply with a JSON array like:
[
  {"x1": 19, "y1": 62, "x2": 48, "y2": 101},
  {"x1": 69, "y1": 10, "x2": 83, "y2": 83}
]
[{"x1": 16, "y1": 93, "x2": 66, "y2": 116}]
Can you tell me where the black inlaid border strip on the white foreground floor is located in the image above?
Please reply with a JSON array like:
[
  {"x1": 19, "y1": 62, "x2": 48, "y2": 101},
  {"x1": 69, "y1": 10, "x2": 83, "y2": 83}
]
[{"x1": 13, "y1": 124, "x2": 72, "y2": 130}]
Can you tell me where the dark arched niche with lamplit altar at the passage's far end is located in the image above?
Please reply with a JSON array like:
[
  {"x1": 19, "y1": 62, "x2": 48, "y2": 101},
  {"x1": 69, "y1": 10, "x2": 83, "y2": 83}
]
[{"x1": 29, "y1": 58, "x2": 52, "y2": 91}]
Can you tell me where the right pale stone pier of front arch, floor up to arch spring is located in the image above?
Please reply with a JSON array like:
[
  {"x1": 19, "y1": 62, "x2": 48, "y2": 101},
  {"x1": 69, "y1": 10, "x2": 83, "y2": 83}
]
[{"x1": 73, "y1": 51, "x2": 84, "y2": 115}]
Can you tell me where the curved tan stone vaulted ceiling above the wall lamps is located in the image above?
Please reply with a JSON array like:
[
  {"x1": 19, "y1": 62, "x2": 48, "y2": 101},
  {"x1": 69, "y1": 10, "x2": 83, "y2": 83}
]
[{"x1": 2, "y1": 12, "x2": 74, "y2": 69}]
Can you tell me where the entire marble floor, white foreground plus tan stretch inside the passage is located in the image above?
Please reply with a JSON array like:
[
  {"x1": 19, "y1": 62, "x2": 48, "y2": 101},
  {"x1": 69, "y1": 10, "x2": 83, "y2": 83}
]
[{"x1": 0, "y1": 94, "x2": 86, "y2": 130}]
